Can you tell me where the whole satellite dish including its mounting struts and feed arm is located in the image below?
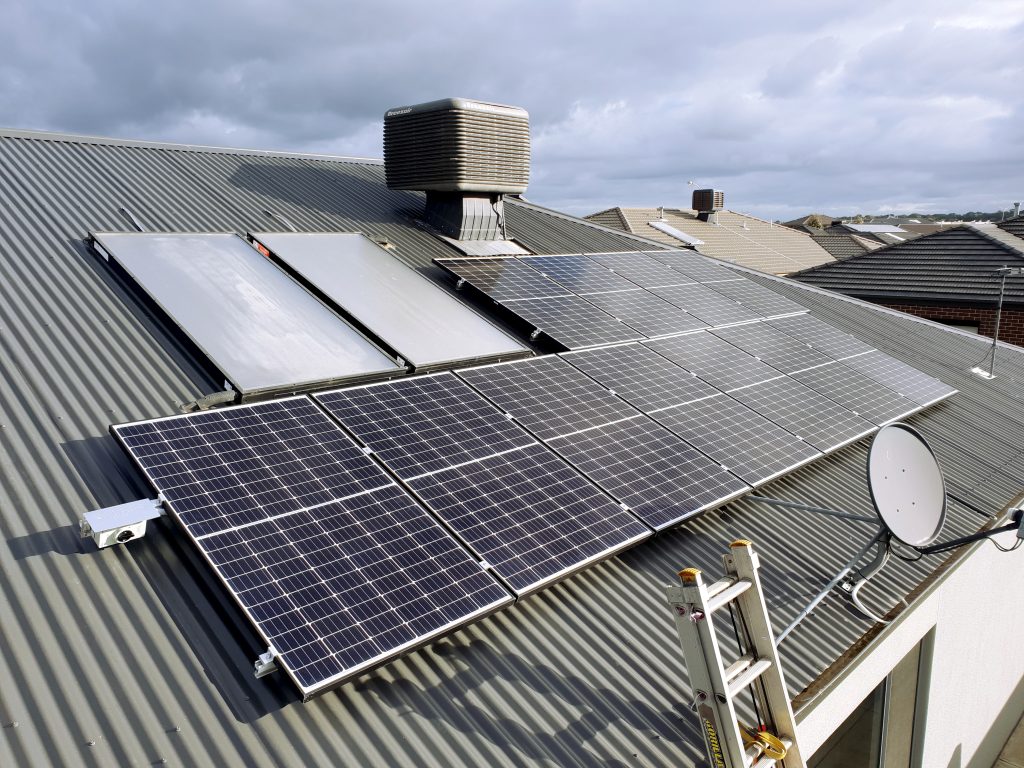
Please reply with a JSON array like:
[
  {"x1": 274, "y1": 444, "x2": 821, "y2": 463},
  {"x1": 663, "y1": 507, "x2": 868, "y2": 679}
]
[{"x1": 748, "y1": 422, "x2": 1024, "y2": 644}]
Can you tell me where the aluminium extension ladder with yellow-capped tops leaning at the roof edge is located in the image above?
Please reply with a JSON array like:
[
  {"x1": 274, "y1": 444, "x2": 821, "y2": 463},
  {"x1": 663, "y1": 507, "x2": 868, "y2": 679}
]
[{"x1": 668, "y1": 540, "x2": 805, "y2": 768}]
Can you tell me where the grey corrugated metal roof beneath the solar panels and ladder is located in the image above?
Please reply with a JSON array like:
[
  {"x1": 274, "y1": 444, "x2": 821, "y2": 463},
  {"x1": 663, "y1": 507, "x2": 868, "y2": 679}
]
[{"x1": 0, "y1": 133, "x2": 1024, "y2": 766}]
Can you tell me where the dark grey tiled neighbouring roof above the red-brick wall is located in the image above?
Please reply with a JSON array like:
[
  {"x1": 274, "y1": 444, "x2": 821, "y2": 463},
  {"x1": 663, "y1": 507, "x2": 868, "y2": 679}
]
[{"x1": 793, "y1": 225, "x2": 1024, "y2": 305}]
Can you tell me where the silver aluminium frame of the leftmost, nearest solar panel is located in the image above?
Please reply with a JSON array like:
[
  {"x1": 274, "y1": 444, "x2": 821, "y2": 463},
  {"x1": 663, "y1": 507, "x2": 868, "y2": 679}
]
[{"x1": 110, "y1": 395, "x2": 515, "y2": 702}]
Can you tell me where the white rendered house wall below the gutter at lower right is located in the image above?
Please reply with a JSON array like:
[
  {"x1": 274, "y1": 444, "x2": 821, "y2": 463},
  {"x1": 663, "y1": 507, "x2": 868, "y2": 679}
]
[{"x1": 782, "y1": 534, "x2": 1024, "y2": 768}]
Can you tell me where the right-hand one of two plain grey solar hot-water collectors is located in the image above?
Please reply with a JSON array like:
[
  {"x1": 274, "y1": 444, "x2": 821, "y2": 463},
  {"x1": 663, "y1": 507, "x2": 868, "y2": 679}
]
[{"x1": 253, "y1": 232, "x2": 529, "y2": 372}]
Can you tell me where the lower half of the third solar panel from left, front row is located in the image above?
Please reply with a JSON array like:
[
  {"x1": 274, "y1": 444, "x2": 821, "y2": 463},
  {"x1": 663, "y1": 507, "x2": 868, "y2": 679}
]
[{"x1": 548, "y1": 416, "x2": 750, "y2": 529}]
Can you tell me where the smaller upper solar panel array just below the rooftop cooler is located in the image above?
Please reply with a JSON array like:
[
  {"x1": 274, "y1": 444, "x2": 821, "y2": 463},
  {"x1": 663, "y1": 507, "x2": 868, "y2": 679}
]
[{"x1": 435, "y1": 251, "x2": 806, "y2": 349}]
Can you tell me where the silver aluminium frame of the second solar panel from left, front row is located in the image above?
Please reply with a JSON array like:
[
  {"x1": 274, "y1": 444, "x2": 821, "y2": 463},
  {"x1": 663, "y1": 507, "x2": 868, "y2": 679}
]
[{"x1": 310, "y1": 376, "x2": 653, "y2": 601}]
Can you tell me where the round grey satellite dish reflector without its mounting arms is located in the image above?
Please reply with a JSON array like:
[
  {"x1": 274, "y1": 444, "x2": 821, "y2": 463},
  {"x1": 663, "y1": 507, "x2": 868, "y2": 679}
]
[{"x1": 867, "y1": 423, "x2": 946, "y2": 547}]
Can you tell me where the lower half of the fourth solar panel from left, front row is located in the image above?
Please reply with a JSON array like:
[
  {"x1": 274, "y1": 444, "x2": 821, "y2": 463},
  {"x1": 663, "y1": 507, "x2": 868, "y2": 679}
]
[{"x1": 651, "y1": 394, "x2": 821, "y2": 485}]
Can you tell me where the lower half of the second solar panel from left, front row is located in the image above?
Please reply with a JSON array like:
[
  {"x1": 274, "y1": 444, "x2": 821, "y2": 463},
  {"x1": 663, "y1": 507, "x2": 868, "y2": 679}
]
[{"x1": 409, "y1": 444, "x2": 650, "y2": 595}]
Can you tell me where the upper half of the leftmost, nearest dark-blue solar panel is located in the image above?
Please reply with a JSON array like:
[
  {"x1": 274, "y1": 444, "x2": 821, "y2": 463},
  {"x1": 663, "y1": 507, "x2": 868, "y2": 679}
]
[{"x1": 113, "y1": 397, "x2": 392, "y2": 536}]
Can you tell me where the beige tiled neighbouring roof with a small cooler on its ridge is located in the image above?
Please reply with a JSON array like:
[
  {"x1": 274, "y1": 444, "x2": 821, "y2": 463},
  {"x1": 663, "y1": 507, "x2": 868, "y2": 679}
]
[{"x1": 586, "y1": 208, "x2": 834, "y2": 274}]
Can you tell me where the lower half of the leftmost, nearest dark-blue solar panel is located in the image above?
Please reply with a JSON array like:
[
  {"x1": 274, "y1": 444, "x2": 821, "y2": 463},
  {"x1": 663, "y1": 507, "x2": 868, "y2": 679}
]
[{"x1": 197, "y1": 485, "x2": 511, "y2": 693}]
